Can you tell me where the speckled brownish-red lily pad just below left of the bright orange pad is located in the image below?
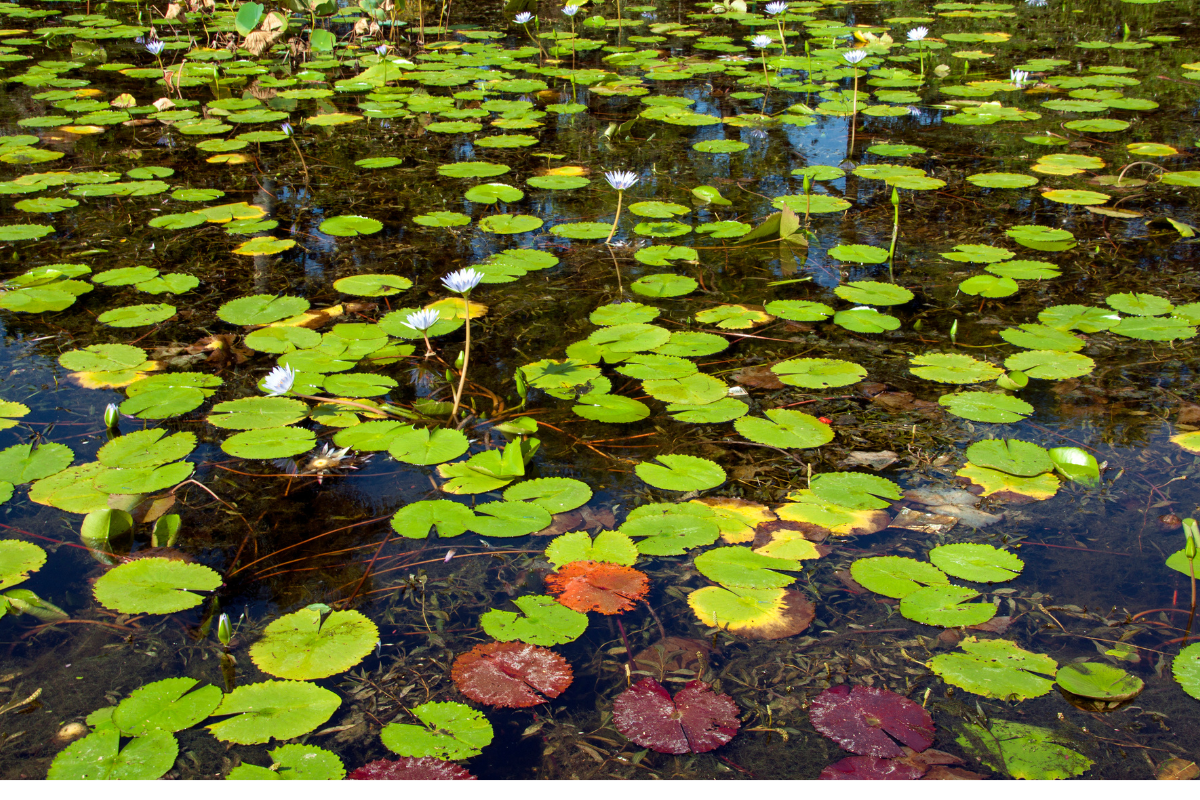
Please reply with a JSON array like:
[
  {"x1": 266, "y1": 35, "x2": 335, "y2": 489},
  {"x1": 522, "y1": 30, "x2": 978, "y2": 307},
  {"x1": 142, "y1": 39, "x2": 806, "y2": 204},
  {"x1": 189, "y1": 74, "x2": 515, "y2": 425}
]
[{"x1": 450, "y1": 642, "x2": 574, "y2": 709}]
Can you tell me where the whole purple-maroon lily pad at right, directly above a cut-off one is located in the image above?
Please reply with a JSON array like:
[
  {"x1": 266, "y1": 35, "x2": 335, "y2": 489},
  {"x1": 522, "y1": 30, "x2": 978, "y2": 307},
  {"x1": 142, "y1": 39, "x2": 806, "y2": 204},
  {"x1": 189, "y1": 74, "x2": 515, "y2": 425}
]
[{"x1": 809, "y1": 685, "x2": 934, "y2": 758}]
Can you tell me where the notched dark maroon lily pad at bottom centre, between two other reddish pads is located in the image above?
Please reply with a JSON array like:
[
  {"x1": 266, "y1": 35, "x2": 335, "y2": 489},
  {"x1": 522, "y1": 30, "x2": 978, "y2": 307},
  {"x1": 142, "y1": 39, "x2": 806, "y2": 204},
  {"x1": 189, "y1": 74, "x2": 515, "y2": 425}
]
[{"x1": 612, "y1": 678, "x2": 738, "y2": 756}]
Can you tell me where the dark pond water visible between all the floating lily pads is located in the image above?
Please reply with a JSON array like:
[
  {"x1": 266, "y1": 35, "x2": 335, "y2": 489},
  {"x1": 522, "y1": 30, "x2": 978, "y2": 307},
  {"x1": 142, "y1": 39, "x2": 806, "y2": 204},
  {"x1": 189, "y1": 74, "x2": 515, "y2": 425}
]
[{"x1": 0, "y1": 2, "x2": 1200, "y2": 778}]
